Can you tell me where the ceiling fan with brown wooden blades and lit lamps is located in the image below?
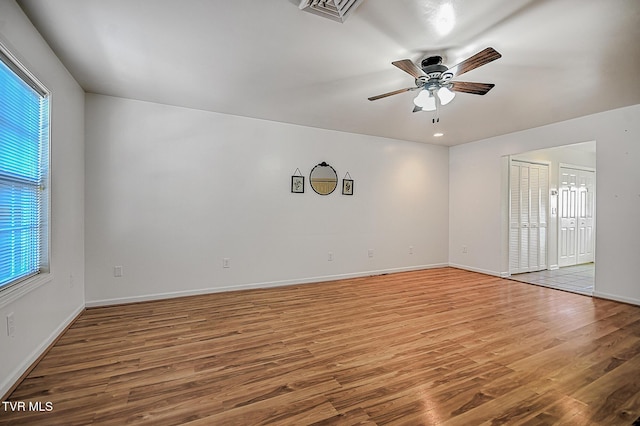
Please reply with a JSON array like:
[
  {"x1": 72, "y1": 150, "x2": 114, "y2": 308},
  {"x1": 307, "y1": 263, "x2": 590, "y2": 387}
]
[{"x1": 368, "y1": 47, "x2": 502, "y2": 123}]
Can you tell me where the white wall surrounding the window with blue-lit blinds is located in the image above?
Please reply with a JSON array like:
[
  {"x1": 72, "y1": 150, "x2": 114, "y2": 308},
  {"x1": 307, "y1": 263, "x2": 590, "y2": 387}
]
[{"x1": 0, "y1": 1, "x2": 84, "y2": 395}]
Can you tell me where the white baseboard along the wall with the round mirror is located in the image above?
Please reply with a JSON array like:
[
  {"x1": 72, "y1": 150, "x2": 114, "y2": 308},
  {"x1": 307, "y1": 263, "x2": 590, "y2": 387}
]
[{"x1": 85, "y1": 263, "x2": 449, "y2": 308}]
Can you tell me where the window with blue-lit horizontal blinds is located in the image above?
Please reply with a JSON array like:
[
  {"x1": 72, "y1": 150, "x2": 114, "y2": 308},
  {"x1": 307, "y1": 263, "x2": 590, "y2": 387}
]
[{"x1": 0, "y1": 46, "x2": 49, "y2": 292}]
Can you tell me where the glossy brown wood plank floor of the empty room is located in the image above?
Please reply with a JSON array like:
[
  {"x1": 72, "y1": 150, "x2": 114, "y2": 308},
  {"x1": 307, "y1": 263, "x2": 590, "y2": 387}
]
[{"x1": 0, "y1": 268, "x2": 640, "y2": 425}]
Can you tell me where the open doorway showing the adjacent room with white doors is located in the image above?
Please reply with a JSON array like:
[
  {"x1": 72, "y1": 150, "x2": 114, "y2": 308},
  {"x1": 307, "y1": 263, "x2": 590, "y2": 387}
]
[{"x1": 503, "y1": 141, "x2": 596, "y2": 295}]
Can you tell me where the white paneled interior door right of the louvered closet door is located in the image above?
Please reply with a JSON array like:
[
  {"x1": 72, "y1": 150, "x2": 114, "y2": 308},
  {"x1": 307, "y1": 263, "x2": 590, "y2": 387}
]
[{"x1": 558, "y1": 167, "x2": 595, "y2": 267}]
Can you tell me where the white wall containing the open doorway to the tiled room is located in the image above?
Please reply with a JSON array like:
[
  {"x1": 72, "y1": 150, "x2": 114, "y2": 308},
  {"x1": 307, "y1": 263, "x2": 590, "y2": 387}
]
[{"x1": 449, "y1": 105, "x2": 640, "y2": 304}]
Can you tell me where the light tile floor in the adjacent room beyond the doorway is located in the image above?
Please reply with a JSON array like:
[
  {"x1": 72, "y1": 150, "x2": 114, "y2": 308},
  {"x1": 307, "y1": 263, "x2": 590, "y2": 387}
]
[{"x1": 510, "y1": 263, "x2": 596, "y2": 296}]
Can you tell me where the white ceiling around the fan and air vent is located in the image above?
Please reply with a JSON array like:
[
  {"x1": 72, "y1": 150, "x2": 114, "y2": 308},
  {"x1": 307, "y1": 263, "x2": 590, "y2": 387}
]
[{"x1": 13, "y1": 0, "x2": 640, "y2": 146}]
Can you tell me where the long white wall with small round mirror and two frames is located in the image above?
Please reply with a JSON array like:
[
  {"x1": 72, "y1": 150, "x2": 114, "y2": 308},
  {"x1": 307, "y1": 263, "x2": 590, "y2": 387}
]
[{"x1": 85, "y1": 94, "x2": 448, "y2": 305}]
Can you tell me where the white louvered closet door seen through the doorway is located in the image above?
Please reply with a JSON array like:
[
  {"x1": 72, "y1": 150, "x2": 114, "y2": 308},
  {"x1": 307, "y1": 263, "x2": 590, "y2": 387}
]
[{"x1": 509, "y1": 161, "x2": 549, "y2": 274}]
